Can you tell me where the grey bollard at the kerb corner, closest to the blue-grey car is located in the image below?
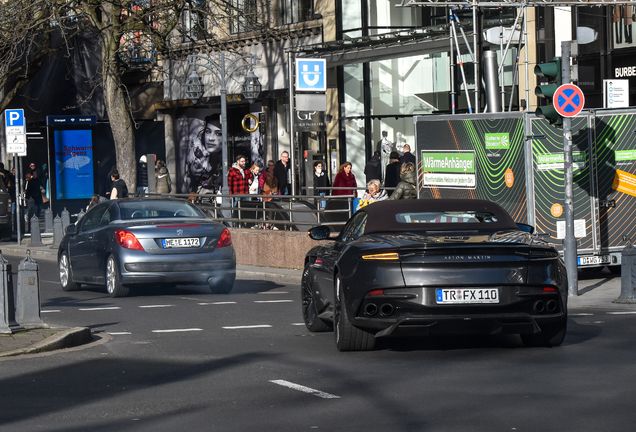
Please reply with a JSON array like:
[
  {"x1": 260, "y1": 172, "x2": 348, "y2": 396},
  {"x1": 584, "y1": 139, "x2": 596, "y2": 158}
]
[{"x1": 15, "y1": 249, "x2": 48, "y2": 328}]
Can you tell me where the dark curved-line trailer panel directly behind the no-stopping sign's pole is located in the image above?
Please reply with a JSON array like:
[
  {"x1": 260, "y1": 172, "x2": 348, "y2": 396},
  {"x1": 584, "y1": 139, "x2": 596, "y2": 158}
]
[{"x1": 530, "y1": 117, "x2": 595, "y2": 251}]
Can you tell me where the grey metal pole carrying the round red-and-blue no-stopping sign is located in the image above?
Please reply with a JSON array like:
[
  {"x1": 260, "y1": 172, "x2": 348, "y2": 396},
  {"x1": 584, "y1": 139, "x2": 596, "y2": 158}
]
[{"x1": 561, "y1": 41, "x2": 579, "y2": 297}]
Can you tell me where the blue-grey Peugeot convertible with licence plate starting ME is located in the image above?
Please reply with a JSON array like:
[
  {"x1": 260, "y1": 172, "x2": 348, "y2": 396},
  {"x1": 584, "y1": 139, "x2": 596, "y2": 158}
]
[{"x1": 58, "y1": 198, "x2": 236, "y2": 297}]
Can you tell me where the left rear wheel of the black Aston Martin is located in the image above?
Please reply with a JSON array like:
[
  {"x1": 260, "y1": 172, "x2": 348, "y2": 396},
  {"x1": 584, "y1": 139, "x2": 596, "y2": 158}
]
[{"x1": 333, "y1": 276, "x2": 375, "y2": 351}]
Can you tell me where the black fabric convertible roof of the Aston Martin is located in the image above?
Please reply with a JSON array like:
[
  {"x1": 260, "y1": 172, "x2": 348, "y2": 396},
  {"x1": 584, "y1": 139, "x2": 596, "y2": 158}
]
[{"x1": 360, "y1": 199, "x2": 519, "y2": 234}]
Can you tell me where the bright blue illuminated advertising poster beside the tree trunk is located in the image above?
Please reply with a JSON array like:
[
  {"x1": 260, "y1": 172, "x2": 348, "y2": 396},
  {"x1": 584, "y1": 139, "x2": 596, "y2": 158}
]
[{"x1": 53, "y1": 130, "x2": 94, "y2": 199}]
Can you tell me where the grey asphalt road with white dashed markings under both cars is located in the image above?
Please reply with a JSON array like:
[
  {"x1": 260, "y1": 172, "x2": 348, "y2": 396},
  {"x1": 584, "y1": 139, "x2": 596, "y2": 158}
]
[{"x1": 0, "y1": 257, "x2": 636, "y2": 432}]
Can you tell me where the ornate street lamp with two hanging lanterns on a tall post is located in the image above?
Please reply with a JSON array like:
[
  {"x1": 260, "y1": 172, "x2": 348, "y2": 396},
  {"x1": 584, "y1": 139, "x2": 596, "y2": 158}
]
[{"x1": 186, "y1": 51, "x2": 261, "y2": 216}]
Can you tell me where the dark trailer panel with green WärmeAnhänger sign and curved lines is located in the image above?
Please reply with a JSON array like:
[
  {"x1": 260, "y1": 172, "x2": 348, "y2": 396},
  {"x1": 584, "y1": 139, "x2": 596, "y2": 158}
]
[{"x1": 416, "y1": 114, "x2": 528, "y2": 222}]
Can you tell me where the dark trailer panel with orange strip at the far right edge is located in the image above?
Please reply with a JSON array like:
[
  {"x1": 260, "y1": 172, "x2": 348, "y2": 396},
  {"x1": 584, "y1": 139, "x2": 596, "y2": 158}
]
[{"x1": 595, "y1": 114, "x2": 636, "y2": 248}]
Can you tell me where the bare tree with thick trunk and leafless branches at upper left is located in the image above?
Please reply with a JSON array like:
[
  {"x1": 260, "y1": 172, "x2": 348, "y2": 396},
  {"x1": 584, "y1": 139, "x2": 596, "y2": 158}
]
[{"x1": 0, "y1": 0, "x2": 270, "y2": 190}]
